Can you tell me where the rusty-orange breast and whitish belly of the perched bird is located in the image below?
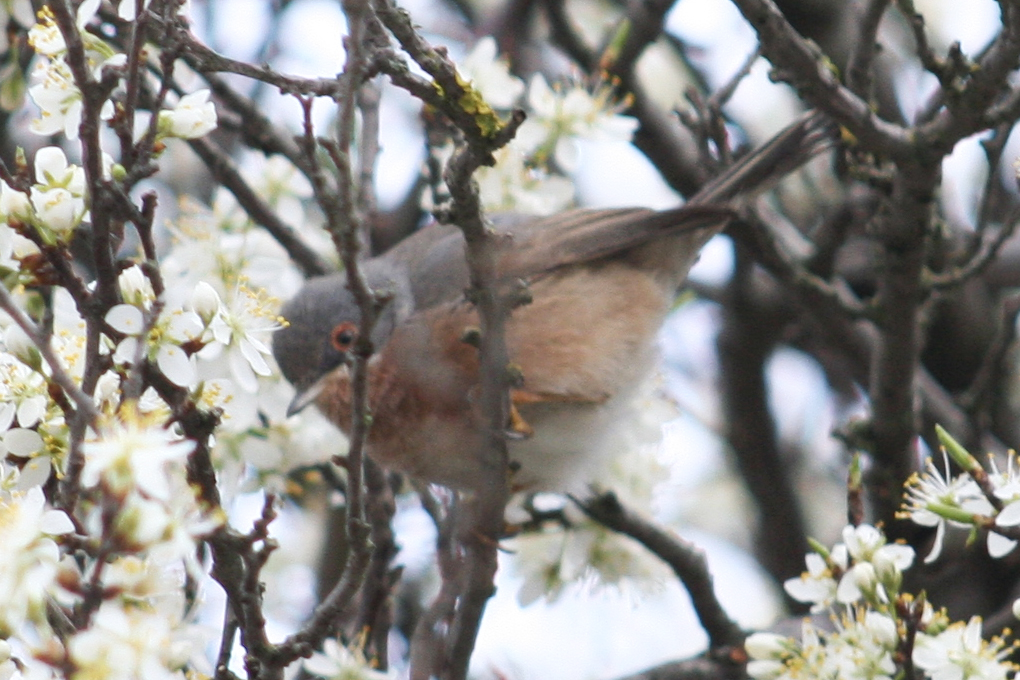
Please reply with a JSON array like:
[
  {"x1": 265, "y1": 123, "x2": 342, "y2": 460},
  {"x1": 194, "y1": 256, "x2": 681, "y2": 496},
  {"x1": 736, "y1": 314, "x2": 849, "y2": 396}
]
[{"x1": 354, "y1": 262, "x2": 671, "y2": 491}]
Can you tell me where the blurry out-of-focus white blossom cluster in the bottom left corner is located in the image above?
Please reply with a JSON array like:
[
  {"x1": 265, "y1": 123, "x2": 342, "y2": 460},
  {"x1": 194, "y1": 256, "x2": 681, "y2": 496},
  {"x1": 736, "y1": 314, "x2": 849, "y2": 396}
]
[{"x1": 0, "y1": 405, "x2": 215, "y2": 680}]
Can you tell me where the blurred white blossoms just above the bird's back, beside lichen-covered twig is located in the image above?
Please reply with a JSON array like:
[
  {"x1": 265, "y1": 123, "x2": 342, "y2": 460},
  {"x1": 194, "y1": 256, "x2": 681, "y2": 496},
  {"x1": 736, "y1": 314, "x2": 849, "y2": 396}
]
[{"x1": 428, "y1": 37, "x2": 638, "y2": 215}]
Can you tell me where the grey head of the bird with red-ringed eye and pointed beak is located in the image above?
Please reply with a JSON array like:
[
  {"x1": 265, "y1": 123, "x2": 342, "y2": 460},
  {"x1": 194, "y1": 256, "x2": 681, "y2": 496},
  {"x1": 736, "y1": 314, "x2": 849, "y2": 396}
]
[{"x1": 272, "y1": 260, "x2": 413, "y2": 415}]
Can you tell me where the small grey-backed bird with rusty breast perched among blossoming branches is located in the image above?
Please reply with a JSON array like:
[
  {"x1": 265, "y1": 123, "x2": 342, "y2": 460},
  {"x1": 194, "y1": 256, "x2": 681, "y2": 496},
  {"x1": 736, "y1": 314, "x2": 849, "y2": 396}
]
[{"x1": 272, "y1": 112, "x2": 834, "y2": 491}]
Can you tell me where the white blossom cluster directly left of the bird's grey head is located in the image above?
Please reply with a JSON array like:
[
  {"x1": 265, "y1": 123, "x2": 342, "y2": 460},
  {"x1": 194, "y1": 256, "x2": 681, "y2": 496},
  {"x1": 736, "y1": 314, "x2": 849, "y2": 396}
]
[{"x1": 148, "y1": 154, "x2": 343, "y2": 493}]
